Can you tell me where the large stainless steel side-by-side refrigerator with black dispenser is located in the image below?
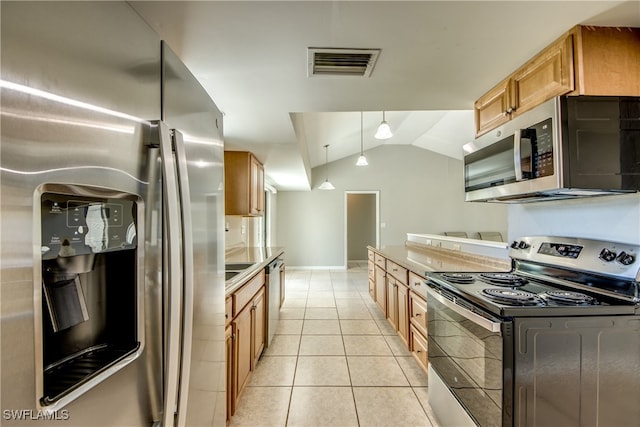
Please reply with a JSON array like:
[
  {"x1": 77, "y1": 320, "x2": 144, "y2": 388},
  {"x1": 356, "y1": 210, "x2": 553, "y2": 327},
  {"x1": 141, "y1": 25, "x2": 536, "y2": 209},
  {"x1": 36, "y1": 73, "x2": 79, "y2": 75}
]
[{"x1": 0, "y1": 1, "x2": 225, "y2": 426}]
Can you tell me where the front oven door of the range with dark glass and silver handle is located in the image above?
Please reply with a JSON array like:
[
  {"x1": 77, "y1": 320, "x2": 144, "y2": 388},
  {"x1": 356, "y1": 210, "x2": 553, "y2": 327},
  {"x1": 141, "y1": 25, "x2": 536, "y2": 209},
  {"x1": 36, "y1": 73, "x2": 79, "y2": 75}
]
[{"x1": 427, "y1": 287, "x2": 512, "y2": 427}]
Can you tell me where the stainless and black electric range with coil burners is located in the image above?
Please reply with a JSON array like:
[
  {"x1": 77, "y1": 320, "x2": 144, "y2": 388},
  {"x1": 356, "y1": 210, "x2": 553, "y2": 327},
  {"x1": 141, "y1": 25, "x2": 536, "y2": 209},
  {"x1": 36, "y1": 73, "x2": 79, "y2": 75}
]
[{"x1": 424, "y1": 236, "x2": 640, "y2": 427}]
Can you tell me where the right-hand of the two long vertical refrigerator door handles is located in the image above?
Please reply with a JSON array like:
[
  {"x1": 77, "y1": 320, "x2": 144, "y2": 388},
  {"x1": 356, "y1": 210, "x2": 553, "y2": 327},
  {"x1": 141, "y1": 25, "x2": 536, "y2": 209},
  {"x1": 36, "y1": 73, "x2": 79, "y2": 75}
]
[{"x1": 172, "y1": 129, "x2": 194, "y2": 427}]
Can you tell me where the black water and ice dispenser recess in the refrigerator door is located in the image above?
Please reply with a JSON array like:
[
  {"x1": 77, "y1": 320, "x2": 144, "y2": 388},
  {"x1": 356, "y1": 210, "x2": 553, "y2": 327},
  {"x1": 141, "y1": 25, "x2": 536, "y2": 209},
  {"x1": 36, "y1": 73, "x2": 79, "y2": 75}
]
[{"x1": 39, "y1": 189, "x2": 142, "y2": 407}]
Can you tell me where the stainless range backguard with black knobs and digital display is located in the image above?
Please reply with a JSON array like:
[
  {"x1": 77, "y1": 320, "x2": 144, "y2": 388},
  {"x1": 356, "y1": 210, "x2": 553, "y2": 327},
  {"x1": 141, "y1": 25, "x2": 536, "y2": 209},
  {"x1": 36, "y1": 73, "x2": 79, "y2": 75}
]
[{"x1": 509, "y1": 236, "x2": 640, "y2": 280}]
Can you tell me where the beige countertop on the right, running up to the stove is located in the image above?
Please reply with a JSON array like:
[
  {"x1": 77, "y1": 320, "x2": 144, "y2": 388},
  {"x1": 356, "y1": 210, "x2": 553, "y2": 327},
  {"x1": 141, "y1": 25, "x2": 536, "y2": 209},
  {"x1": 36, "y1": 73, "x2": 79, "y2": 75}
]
[{"x1": 369, "y1": 242, "x2": 511, "y2": 276}]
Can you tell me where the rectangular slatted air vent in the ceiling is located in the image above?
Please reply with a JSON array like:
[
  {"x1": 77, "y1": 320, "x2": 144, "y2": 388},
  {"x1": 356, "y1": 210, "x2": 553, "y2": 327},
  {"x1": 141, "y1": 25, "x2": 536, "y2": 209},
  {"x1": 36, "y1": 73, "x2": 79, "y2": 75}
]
[{"x1": 307, "y1": 47, "x2": 380, "y2": 77}]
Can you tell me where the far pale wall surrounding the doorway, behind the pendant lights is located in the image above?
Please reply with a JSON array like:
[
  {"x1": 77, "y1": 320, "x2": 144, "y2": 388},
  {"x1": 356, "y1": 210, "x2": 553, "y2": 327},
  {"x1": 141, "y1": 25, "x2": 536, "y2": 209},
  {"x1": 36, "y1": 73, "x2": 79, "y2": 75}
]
[{"x1": 277, "y1": 144, "x2": 507, "y2": 267}]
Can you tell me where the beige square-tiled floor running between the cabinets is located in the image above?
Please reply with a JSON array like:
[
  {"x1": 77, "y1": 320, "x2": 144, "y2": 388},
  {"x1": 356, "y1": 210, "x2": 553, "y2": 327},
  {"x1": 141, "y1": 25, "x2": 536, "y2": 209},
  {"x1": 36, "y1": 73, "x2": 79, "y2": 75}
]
[{"x1": 229, "y1": 262, "x2": 436, "y2": 427}]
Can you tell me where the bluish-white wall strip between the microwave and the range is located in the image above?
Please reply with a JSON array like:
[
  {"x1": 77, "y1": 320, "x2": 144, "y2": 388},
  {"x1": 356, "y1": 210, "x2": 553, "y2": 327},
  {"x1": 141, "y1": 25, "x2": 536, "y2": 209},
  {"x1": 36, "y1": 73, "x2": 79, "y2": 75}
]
[{"x1": 509, "y1": 194, "x2": 640, "y2": 245}]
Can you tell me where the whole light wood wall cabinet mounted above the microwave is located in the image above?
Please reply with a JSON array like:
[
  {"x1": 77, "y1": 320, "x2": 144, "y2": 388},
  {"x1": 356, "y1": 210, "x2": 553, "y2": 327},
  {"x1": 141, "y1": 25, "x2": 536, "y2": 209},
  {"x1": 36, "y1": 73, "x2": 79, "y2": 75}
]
[{"x1": 474, "y1": 26, "x2": 640, "y2": 136}]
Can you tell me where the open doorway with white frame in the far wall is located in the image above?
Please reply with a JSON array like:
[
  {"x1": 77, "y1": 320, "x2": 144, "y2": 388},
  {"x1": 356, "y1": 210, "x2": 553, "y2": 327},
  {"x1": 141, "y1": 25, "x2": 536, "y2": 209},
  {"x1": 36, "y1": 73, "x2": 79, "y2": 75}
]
[{"x1": 344, "y1": 191, "x2": 380, "y2": 268}]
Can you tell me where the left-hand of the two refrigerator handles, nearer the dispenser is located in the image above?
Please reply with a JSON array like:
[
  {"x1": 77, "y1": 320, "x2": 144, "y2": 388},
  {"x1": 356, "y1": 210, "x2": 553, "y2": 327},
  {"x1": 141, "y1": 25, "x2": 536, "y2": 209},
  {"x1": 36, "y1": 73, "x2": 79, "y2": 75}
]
[{"x1": 156, "y1": 121, "x2": 182, "y2": 427}]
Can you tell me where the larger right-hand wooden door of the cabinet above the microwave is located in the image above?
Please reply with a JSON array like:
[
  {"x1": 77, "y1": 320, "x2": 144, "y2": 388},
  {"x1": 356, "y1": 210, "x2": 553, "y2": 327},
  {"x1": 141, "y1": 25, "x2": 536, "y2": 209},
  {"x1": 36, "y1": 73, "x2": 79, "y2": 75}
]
[{"x1": 511, "y1": 35, "x2": 574, "y2": 116}]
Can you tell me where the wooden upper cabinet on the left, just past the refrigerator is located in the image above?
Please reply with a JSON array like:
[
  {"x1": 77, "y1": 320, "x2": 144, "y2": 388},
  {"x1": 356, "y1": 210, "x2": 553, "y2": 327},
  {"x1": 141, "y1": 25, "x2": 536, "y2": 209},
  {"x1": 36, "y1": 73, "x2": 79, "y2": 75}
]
[{"x1": 224, "y1": 151, "x2": 264, "y2": 216}]
